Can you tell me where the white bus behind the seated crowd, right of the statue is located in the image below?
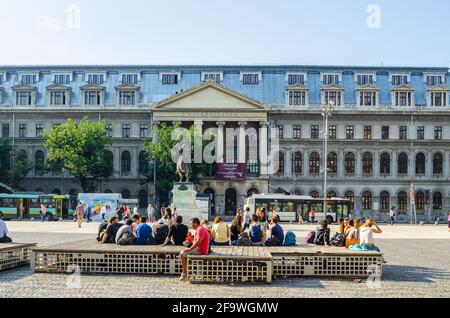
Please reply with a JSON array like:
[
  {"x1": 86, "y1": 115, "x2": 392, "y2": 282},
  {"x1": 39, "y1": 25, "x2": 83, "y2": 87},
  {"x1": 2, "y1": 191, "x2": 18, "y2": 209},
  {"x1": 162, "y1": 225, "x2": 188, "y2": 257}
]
[{"x1": 245, "y1": 194, "x2": 351, "y2": 224}]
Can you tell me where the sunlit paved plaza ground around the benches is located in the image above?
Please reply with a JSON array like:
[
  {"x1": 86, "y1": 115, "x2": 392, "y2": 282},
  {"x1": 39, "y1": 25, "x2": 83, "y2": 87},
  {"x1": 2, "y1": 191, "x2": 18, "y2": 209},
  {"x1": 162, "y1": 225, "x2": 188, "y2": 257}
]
[{"x1": 0, "y1": 222, "x2": 450, "y2": 298}]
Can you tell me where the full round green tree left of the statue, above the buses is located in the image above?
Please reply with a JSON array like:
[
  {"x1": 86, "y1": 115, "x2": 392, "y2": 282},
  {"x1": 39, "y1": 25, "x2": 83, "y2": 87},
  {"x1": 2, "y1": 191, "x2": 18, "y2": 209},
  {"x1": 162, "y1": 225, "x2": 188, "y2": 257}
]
[{"x1": 43, "y1": 119, "x2": 114, "y2": 193}]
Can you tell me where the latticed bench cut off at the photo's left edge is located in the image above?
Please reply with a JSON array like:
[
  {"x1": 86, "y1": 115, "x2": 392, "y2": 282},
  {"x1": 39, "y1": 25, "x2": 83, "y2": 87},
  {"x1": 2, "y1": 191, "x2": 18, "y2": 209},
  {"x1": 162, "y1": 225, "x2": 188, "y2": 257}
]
[{"x1": 0, "y1": 243, "x2": 36, "y2": 271}]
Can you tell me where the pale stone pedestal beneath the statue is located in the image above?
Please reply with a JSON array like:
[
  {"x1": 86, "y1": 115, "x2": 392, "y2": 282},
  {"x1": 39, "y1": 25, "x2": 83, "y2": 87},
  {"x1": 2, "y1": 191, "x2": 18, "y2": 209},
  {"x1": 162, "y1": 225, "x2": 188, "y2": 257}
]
[{"x1": 172, "y1": 182, "x2": 202, "y2": 224}]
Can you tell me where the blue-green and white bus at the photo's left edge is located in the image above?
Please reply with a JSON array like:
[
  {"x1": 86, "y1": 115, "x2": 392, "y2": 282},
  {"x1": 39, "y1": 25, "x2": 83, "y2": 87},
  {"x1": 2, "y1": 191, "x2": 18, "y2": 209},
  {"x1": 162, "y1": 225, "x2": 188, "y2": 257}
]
[{"x1": 0, "y1": 193, "x2": 74, "y2": 220}]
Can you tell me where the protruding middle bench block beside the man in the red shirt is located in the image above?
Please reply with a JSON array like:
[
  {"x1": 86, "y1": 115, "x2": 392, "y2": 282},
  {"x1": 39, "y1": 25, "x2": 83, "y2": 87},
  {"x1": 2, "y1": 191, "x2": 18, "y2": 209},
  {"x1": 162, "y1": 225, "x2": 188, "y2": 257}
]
[{"x1": 188, "y1": 246, "x2": 272, "y2": 284}]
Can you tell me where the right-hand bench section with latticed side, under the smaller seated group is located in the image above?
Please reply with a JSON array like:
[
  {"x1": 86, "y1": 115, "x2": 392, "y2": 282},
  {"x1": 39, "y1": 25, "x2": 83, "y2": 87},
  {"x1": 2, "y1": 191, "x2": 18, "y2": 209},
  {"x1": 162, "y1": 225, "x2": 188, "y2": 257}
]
[{"x1": 268, "y1": 245, "x2": 384, "y2": 278}]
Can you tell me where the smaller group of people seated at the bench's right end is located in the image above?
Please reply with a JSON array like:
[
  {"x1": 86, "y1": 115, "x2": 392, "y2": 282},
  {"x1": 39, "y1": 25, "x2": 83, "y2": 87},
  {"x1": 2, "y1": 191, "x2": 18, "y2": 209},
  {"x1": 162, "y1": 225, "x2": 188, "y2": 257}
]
[{"x1": 306, "y1": 218, "x2": 382, "y2": 251}]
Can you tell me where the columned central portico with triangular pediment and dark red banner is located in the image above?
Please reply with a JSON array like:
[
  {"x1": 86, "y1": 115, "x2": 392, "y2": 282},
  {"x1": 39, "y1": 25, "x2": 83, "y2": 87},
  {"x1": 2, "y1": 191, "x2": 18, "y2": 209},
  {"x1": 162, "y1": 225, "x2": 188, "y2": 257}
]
[{"x1": 152, "y1": 81, "x2": 269, "y2": 217}]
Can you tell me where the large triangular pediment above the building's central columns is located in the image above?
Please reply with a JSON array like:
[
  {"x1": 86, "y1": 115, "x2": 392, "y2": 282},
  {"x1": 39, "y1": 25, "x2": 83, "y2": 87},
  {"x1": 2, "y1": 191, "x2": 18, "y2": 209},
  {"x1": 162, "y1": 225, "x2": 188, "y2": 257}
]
[{"x1": 153, "y1": 82, "x2": 268, "y2": 111}]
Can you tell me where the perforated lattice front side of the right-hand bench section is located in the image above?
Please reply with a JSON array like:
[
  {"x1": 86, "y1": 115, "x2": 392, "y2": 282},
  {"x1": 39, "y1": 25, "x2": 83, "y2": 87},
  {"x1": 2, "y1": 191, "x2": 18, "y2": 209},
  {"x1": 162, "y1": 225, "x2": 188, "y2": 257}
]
[{"x1": 273, "y1": 255, "x2": 383, "y2": 278}]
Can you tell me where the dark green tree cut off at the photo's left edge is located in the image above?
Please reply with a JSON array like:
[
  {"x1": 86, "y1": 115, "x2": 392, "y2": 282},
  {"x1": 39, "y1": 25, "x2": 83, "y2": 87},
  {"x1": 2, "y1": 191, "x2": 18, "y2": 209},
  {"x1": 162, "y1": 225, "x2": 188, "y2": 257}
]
[{"x1": 0, "y1": 138, "x2": 35, "y2": 189}]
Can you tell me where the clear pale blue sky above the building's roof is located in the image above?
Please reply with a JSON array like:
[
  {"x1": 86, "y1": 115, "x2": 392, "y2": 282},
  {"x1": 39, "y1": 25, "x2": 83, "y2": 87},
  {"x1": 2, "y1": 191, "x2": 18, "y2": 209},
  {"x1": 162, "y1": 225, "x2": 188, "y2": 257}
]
[{"x1": 0, "y1": 0, "x2": 450, "y2": 66}]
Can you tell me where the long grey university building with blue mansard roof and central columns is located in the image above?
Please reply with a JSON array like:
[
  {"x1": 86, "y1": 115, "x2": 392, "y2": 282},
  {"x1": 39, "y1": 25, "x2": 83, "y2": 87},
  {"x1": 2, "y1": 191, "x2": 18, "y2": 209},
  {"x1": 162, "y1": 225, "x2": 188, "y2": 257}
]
[{"x1": 0, "y1": 66, "x2": 450, "y2": 221}]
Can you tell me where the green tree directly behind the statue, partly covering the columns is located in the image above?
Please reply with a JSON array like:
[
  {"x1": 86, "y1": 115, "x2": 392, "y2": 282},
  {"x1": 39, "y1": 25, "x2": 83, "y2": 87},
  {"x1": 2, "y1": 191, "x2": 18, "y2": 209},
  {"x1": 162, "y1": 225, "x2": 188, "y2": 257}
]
[{"x1": 142, "y1": 124, "x2": 214, "y2": 202}]
